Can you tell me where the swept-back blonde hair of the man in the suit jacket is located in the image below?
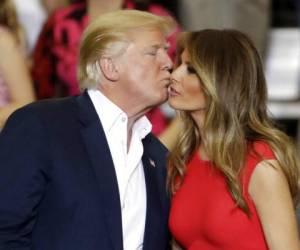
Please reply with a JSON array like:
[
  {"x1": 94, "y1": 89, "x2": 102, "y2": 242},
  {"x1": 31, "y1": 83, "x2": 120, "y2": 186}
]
[{"x1": 77, "y1": 10, "x2": 175, "y2": 90}]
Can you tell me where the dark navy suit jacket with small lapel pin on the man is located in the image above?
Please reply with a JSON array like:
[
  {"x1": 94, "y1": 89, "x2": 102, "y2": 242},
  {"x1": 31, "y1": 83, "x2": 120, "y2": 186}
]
[{"x1": 0, "y1": 93, "x2": 169, "y2": 250}]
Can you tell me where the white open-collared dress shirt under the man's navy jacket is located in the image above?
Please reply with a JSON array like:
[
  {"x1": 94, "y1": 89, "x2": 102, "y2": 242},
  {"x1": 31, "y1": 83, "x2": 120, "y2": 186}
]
[{"x1": 88, "y1": 89, "x2": 152, "y2": 250}]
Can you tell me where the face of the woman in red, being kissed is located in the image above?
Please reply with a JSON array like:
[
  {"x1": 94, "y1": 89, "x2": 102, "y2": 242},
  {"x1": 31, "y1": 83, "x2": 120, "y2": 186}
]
[{"x1": 169, "y1": 49, "x2": 206, "y2": 112}]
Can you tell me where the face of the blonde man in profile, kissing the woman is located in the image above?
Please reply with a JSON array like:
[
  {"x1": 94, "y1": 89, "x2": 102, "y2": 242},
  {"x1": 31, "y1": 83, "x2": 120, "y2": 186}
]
[{"x1": 118, "y1": 29, "x2": 172, "y2": 113}]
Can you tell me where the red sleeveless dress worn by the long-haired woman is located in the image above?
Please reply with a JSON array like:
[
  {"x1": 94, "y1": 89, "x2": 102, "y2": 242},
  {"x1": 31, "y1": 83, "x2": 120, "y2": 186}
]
[{"x1": 169, "y1": 141, "x2": 275, "y2": 250}]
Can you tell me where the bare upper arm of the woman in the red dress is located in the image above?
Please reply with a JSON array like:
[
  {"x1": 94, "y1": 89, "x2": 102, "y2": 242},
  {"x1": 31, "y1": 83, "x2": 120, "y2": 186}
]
[{"x1": 249, "y1": 160, "x2": 300, "y2": 250}]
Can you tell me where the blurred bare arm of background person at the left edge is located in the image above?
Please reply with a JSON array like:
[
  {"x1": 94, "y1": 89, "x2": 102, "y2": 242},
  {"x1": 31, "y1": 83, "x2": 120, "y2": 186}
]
[{"x1": 0, "y1": 30, "x2": 35, "y2": 128}]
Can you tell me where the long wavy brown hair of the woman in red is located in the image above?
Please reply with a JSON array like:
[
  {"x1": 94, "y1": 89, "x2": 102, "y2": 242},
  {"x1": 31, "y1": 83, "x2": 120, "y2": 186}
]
[{"x1": 168, "y1": 30, "x2": 299, "y2": 214}]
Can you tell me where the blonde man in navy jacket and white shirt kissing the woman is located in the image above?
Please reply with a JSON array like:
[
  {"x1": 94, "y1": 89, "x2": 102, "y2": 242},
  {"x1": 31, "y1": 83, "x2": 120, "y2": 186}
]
[{"x1": 0, "y1": 10, "x2": 173, "y2": 250}]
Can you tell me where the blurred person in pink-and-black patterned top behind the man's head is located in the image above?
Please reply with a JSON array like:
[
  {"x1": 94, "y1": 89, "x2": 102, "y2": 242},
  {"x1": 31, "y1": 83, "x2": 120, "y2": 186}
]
[{"x1": 32, "y1": 0, "x2": 179, "y2": 134}]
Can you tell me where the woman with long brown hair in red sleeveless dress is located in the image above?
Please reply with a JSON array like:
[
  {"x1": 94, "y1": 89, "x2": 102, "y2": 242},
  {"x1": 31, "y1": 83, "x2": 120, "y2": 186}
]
[{"x1": 168, "y1": 30, "x2": 300, "y2": 250}]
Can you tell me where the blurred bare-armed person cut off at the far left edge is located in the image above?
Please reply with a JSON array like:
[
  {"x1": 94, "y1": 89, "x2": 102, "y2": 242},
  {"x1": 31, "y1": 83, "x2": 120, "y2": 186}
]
[{"x1": 0, "y1": 0, "x2": 34, "y2": 129}]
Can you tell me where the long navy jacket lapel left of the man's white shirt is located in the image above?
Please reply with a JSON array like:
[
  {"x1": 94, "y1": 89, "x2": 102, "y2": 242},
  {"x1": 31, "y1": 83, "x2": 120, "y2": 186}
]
[{"x1": 77, "y1": 92, "x2": 123, "y2": 250}]
